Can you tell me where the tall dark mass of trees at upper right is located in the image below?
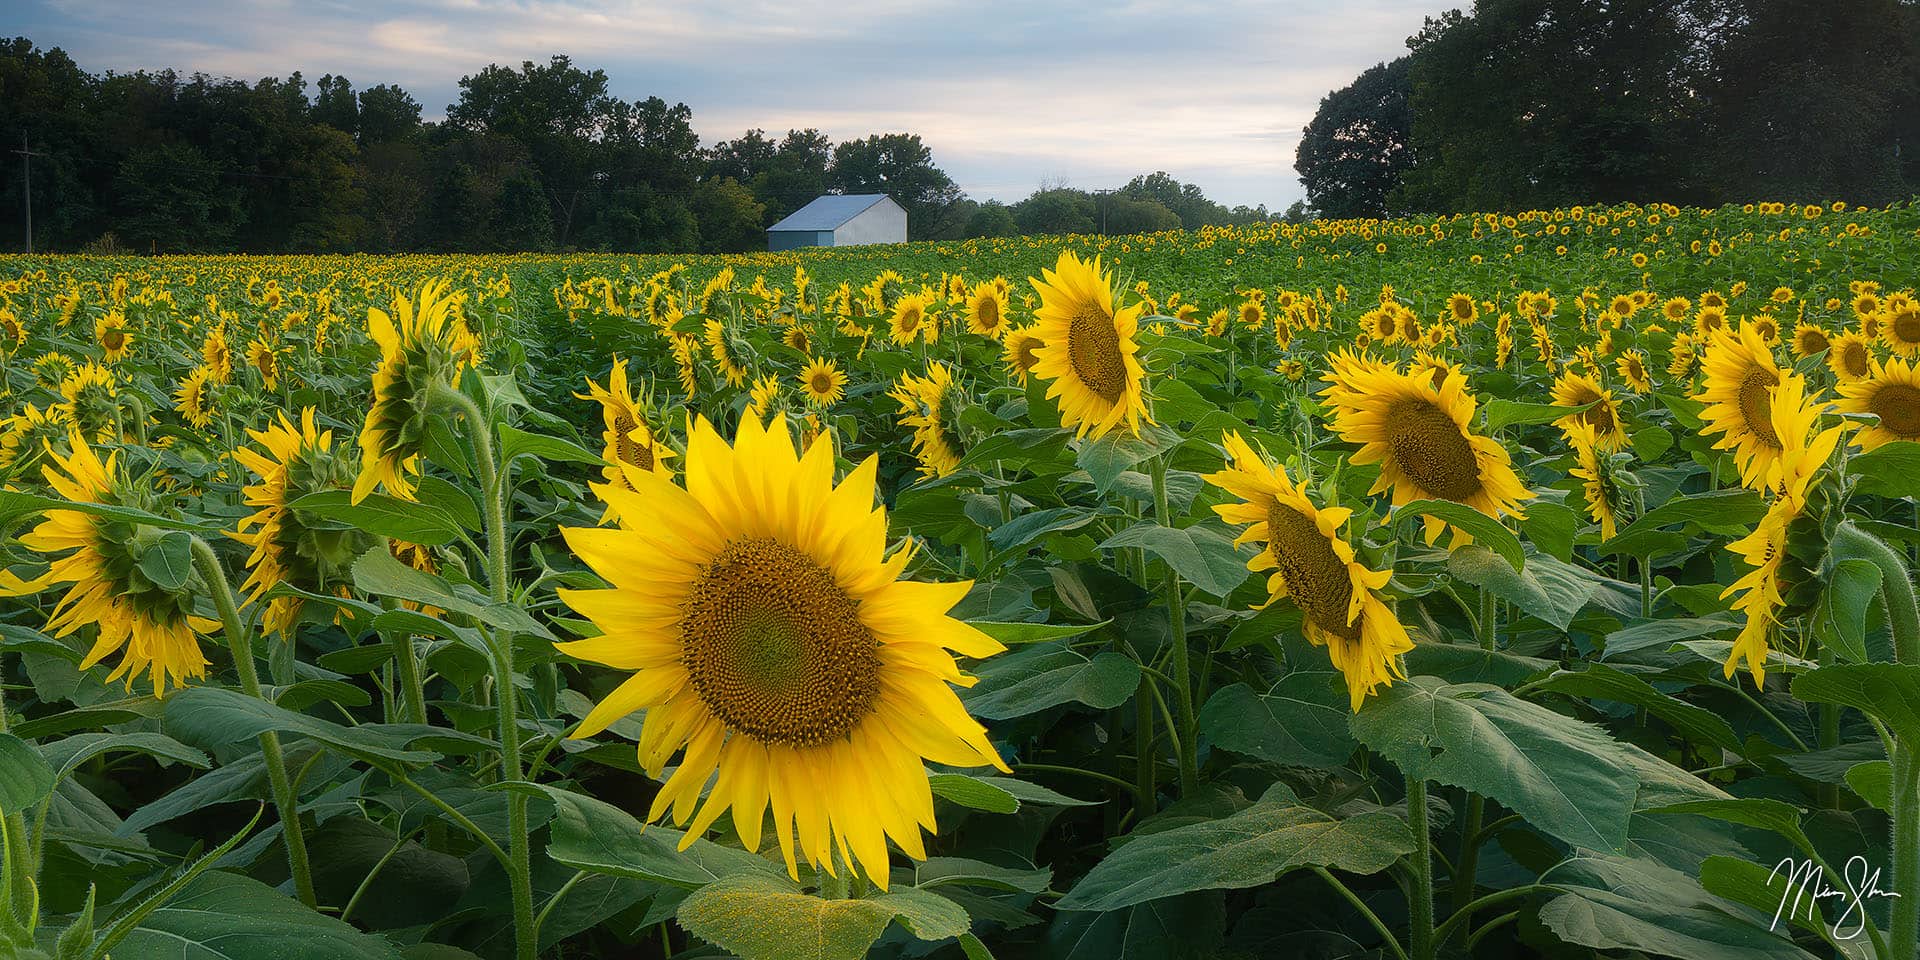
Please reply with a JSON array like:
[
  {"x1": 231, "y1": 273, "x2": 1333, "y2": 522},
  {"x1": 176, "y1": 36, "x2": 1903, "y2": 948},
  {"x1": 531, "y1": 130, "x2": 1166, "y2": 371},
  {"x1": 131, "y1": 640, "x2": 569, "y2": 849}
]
[{"x1": 1294, "y1": 0, "x2": 1920, "y2": 217}]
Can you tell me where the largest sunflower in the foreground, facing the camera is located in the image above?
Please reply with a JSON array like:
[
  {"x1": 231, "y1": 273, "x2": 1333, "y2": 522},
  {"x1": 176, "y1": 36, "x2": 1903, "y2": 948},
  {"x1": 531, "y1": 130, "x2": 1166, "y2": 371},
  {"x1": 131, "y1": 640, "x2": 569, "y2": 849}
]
[{"x1": 559, "y1": 417, "x2": 1006, "y2": 889}]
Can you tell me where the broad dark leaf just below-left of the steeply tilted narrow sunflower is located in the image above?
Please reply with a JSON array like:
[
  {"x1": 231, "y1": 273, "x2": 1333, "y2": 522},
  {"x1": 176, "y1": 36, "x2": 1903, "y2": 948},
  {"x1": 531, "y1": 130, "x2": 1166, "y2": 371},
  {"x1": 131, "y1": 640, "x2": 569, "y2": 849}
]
[{"x1": 1198, "y1": 670, "x2": 1354, "y2": 770}]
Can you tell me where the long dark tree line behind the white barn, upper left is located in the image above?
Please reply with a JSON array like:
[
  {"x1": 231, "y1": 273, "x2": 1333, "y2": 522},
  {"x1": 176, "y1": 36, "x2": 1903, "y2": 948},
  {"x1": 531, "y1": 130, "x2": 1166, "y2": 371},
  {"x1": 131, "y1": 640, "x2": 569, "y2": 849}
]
[{"x1": 0, "y1": 36, "x2": 1267, "y2": 253}]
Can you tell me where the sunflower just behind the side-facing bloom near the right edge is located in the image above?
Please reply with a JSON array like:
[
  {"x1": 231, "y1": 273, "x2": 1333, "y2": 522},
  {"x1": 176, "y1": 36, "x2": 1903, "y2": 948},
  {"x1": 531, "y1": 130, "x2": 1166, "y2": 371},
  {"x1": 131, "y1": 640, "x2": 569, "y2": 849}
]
[{"x1": 1693, "y1": 326, "x2": 1782, "y2": 490}]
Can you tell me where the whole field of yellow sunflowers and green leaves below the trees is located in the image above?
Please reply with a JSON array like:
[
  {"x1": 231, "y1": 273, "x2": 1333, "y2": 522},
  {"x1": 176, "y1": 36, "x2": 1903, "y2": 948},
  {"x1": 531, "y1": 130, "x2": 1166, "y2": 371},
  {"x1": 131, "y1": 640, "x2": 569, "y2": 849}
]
[{"x1": 0, "y1": 202, "x2": 1920, "y2": 960}]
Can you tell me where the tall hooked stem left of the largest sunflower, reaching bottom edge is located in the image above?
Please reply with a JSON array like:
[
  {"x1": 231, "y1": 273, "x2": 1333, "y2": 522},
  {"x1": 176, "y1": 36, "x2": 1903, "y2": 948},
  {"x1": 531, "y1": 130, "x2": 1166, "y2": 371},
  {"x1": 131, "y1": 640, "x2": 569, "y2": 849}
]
[{"x1": 428, "y1": 380, "x2": 540, "y2": 960}]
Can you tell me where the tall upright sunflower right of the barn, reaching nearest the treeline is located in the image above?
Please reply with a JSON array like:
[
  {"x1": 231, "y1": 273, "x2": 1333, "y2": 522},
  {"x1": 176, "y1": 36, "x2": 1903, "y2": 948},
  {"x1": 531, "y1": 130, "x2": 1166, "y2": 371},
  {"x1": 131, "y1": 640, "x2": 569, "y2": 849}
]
[{"x1": 1029, "y1": 250, "x2": 1154, "y2": 440}]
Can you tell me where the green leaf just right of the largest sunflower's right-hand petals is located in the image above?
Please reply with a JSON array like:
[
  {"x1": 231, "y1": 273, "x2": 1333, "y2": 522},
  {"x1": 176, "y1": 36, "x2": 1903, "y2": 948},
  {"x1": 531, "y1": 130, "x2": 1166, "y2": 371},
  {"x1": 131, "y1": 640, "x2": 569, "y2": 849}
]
[{"x1": 960, "y1": 645, "x2": 1140, "y2": 720}]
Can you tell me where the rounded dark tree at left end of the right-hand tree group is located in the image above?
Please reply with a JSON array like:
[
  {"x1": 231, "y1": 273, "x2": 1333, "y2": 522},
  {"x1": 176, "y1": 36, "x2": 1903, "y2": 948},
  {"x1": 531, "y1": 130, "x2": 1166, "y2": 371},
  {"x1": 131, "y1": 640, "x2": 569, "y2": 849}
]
[{"x1": 1294, "y1": 58, "x2": 1413, "y2": 219}]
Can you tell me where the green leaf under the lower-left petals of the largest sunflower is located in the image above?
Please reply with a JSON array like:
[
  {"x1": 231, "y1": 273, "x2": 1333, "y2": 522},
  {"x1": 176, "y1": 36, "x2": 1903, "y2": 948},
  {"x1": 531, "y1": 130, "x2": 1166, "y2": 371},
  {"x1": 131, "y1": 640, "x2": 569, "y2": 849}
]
[{"x1": 511, "y1": 783, "x2": 781, "y2": 889}]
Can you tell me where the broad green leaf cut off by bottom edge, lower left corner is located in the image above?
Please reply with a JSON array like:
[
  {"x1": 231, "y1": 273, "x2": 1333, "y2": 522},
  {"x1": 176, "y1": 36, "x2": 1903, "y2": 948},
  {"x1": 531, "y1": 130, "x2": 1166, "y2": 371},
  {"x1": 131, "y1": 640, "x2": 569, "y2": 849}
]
[{"x1": 113, "y1": 870, "x2": 399, "y2": 960}]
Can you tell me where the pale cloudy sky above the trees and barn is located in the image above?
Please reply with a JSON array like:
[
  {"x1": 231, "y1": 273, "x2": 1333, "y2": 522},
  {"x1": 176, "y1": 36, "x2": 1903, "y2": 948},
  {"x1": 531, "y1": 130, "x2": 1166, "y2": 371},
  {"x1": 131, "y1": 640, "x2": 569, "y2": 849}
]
[{"x1": 11, "y1": 0, "x2": 1428, "y2": 209}]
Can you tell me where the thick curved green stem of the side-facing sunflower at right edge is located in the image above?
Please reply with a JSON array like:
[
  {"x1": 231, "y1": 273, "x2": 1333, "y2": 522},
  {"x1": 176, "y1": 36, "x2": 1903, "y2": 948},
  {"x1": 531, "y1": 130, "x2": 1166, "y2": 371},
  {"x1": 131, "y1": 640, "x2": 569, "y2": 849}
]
[{"x1": 1834, "y1": 522, "x2": 1920, "y2": 958}]
